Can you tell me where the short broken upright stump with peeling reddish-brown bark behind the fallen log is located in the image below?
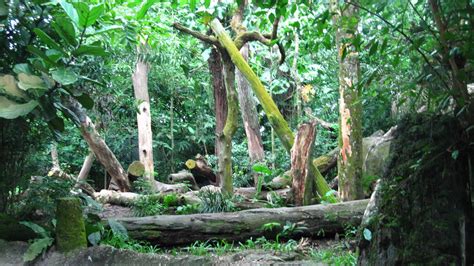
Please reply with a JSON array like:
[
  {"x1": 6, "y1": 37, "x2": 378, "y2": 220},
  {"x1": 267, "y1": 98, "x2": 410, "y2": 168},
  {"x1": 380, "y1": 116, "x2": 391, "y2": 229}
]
[{"x1": 291, "y1": 122, "x2": 316, "y2": 206}]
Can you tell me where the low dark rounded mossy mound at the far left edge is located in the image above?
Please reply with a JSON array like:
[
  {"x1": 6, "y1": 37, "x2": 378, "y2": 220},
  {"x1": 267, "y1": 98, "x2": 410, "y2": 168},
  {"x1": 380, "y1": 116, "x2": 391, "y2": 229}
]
[{"x1": 0, "y1": 213, "x2": 36, "y2": 241}]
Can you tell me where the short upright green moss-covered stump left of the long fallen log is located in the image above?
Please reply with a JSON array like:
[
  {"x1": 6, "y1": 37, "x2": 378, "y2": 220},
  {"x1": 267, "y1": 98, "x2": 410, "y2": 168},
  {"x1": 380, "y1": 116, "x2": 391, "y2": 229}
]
[{"x1": 56, "y1": 197, "x2": 87, "y2": 252}]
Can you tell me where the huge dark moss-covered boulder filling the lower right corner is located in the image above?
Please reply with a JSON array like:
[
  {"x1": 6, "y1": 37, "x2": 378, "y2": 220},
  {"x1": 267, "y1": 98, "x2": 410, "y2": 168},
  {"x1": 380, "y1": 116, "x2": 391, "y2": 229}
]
[{"x1": 358, "y1": 114, "x2": 474, "y2": 265}]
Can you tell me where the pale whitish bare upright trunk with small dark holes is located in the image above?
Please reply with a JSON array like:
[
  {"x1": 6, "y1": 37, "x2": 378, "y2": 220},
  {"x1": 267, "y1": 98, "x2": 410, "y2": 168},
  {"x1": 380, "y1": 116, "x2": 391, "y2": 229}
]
[{"x1": 132, "y1": 59, "x2": 154, "y2": 180}]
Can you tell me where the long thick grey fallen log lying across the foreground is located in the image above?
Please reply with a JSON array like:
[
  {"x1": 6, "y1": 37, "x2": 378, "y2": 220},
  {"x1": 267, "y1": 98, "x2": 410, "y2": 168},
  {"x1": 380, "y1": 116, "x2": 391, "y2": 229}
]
[{"x1": 113, "y1": 200, "x2": 368, "y2": 246}]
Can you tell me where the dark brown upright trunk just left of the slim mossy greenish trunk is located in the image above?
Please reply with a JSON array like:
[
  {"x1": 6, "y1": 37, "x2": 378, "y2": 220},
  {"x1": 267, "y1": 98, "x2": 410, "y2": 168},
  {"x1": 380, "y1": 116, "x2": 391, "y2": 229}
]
[{"x1": 208, "y1": 48, "x2": 227, "y2": 184}]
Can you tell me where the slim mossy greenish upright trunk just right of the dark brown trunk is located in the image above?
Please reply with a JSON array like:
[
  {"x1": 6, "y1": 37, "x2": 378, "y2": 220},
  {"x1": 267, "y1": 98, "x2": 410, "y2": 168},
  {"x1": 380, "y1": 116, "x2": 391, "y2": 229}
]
[{"x1": 219, "y1": 50, "x2": 239, "y2": 194}]
